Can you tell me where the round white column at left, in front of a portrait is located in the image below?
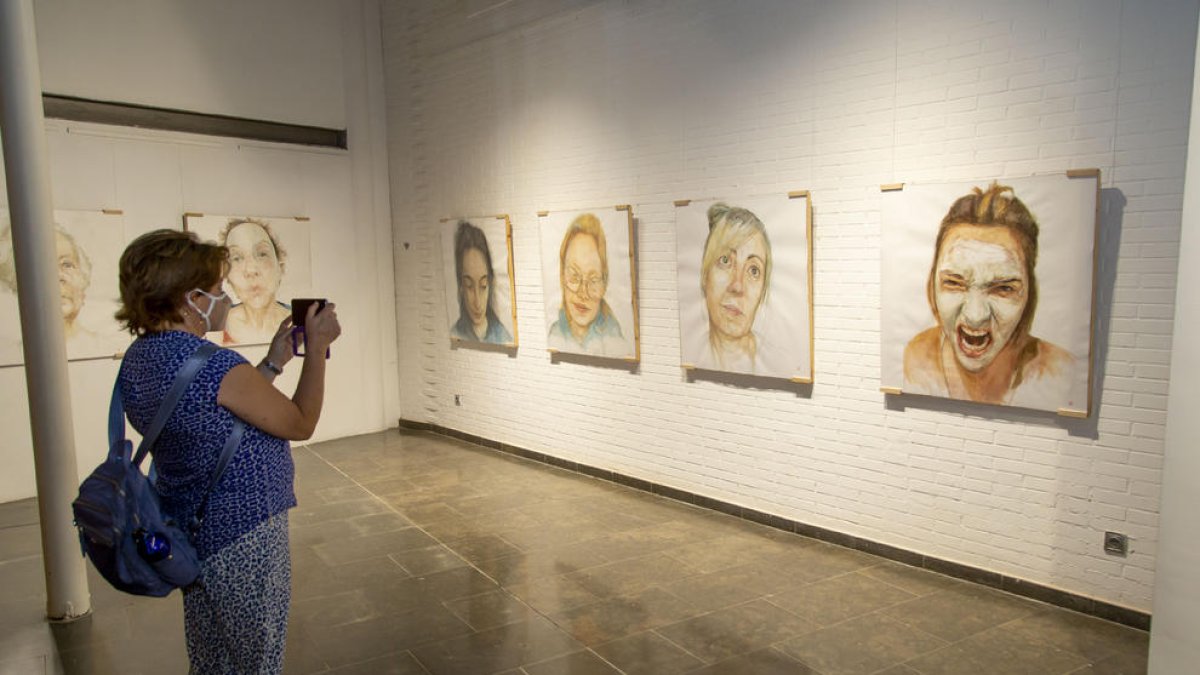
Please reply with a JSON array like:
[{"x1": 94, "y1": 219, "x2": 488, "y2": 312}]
[{"x1": 0, "y1": 0, "x2": 91, "y2": 621}]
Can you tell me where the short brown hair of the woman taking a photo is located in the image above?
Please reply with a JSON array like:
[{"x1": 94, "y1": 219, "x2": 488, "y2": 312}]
[{"x1": 116, "y1": 229, "x2": 229, "y2": 335}]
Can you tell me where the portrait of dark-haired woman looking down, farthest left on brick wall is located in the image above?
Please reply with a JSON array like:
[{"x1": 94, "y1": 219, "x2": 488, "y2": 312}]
[{"x1": 442, "y1": 216, "x2": 517, "y2": 346}]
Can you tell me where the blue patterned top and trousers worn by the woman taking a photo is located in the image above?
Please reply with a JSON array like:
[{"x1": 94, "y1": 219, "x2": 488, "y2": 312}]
[{"x1": 120, "y1": 330, "x2": 296, "y2": 674}]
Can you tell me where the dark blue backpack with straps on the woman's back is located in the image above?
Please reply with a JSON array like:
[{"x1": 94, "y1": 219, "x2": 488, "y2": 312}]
[{"x1": 71, "y1": 342, "x2": 245, "y2": 597}]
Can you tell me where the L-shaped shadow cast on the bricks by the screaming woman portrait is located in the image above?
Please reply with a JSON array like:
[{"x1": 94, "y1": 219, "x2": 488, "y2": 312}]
[{"x1": 886, "y1": 187, "x2": 1127, "y2": 441}]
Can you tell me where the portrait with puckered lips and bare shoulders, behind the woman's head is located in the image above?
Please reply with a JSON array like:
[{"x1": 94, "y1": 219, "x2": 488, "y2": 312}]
[{"x1": 184, "y1": 214, "x2": 312, "y2": 345}]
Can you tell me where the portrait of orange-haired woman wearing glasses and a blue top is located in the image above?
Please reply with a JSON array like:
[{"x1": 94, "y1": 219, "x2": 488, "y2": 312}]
[{"x1": 539, "y1": 207, "x2": 640, "y2": 360}]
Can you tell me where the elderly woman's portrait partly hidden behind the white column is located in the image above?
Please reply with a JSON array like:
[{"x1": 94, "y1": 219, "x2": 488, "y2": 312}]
[{"x1": 0, "y1": 209, "x2": 130, "y2": 365}]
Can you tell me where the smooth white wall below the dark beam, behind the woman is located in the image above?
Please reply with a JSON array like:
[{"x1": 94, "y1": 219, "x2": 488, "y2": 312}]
[{"x1": 0, "y1": 120, "x2": 395, "y2": 502}]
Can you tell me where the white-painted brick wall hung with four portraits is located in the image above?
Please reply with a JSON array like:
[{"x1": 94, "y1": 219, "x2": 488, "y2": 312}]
[{"x1": 384, "y1": 0, "x2": 1198, "y2": 610}]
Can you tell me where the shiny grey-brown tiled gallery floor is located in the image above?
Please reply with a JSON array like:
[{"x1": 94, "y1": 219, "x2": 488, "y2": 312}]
[{"x1": 0, "y1": 431, "x2": 1147, "y2": 675}]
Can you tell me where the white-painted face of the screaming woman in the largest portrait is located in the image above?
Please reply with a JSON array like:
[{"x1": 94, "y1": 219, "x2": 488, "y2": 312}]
[{"x1": 934, "y1": 225, "x2": 1030, "y2": 372}]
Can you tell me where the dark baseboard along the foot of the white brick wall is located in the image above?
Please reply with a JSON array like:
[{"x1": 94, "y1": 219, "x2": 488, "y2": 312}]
[{"x1": 400, "y1": 419, "x2": 1151, "y2": 631}]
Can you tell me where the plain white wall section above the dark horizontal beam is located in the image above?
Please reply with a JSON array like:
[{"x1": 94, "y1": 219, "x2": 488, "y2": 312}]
[{"x1": 35, "y1": 0, "x2": 347, "y2": 129}]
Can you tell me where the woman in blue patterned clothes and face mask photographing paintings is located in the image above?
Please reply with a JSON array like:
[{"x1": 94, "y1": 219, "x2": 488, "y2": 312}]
[{"x1": 116, "y1": 229, "x2": 341, "y2": 674}]
